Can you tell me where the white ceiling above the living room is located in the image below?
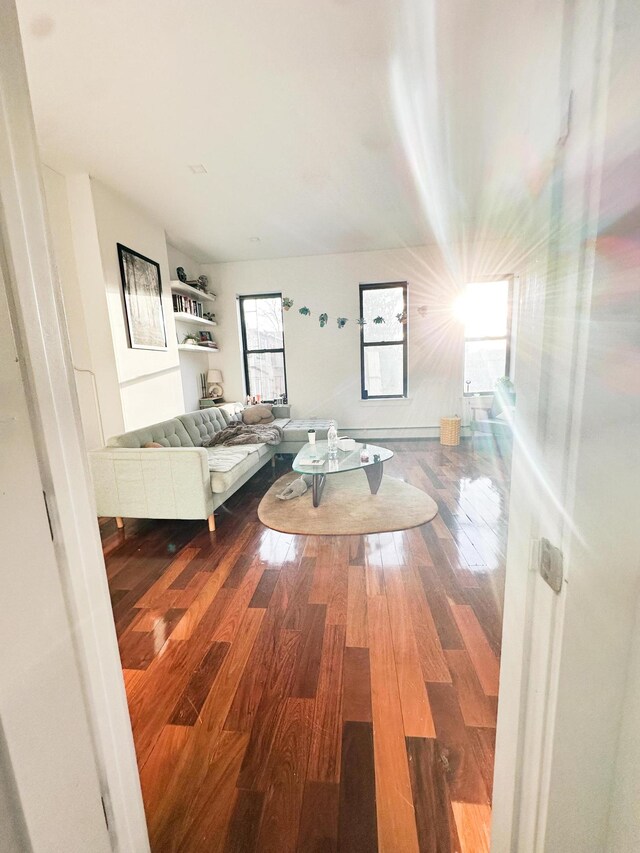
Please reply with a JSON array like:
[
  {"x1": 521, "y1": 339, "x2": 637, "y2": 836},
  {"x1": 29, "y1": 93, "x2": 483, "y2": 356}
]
[{"x1": 18, "y1": 0, "x2": 535, "y2": 262}]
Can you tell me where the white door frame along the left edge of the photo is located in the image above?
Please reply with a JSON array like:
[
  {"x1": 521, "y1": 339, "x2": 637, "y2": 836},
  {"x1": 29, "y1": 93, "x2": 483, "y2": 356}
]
[{"x1": 0, "y1": 0, "x2": 149, "y2": 853}]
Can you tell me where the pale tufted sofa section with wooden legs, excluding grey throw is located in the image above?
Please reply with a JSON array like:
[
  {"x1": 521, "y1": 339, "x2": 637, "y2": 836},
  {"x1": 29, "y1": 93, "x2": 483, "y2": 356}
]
[{"x1": 89, "y1": 408, "x2": 288, "y2": 530}]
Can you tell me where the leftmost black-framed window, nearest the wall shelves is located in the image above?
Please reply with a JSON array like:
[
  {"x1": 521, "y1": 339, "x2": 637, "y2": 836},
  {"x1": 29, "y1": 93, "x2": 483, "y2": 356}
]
[{"x1": 238, "y1": 293, "x2": 287, "y2": 401}]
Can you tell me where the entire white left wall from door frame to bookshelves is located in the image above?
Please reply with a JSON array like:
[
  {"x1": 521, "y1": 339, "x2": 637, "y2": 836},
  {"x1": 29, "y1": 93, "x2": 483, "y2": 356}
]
[{"x1": 42, "y1": 173, "x2": 212, "y2": 442}]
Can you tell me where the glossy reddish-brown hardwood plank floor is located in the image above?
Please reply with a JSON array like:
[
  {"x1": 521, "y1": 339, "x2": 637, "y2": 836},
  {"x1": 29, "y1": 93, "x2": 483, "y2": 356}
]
[{"x1": 101, "y1": 441, "x2": 508, "y2": 853}]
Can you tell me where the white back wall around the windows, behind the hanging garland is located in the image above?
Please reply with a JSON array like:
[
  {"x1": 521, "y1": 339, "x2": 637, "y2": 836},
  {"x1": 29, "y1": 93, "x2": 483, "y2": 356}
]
[{"x1": 202, "y1": 245, "x2": 517, "y2": 437}]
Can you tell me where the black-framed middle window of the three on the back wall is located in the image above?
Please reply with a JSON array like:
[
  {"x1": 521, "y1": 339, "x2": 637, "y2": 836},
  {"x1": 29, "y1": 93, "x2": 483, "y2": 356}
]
[{"x1": 360, "y1": 282, "x2": 407, "y2": 400}]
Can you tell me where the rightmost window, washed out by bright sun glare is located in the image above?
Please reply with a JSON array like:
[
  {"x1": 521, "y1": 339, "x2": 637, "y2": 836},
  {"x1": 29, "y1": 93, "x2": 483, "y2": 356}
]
[{"x1": 456, "y1": 279, "x2": 511, "y2": 394}]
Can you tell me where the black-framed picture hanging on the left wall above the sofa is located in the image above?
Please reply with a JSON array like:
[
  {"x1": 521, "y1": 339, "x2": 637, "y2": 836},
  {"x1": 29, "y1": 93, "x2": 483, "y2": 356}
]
[{"x1": 118, "y1": 243, "x2": 167, "y2": 350}]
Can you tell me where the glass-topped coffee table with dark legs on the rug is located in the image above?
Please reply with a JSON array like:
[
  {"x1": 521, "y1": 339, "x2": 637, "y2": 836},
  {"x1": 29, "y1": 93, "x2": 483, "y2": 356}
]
[{"x1": 293, "y1": 441, "x2": 393, "y2": 507}]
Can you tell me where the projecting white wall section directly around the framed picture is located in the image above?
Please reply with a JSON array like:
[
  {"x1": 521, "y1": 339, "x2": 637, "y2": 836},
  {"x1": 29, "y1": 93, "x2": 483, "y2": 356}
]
[{"x1": 91, "y1": 179, "x2": 184, "y2": 430}]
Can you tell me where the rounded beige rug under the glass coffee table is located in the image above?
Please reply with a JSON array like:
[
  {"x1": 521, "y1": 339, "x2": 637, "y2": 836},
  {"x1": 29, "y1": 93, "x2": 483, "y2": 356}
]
[{"x1": 258, "y1": 471, "x2": 438, "y2": 534}]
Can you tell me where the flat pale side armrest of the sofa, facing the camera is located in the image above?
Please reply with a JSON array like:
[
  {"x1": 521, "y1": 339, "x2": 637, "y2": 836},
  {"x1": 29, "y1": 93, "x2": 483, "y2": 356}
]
[{"x1": 89, "y1": 447, "x2": 213, "y2": 518}]
